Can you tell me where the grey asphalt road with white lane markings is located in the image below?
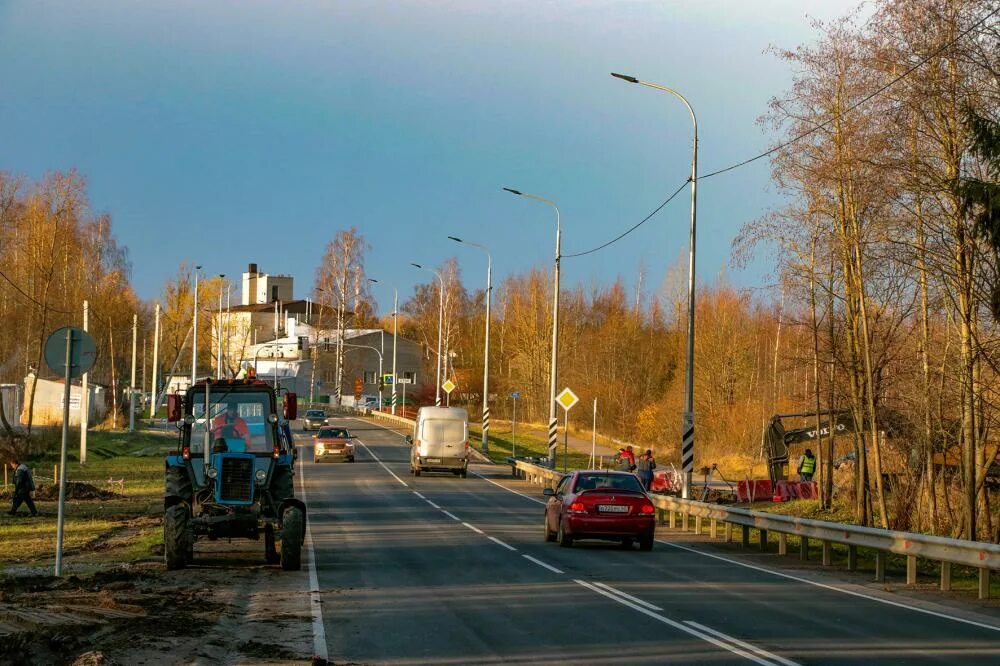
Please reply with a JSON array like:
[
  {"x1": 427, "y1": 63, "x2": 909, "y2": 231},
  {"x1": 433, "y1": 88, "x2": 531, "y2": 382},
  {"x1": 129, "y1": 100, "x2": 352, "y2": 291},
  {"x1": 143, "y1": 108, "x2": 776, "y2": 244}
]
[{"x1": 299, "y1": 419, "x2": 1000, "y2": 665}]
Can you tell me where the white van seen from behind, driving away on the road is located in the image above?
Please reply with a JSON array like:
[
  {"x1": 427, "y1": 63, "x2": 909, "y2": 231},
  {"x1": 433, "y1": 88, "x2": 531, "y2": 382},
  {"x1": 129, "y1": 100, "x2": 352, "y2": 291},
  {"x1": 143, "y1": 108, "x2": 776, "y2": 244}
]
[{"x1": 406, "y1": 407, "x2": 469, "y2": 478}]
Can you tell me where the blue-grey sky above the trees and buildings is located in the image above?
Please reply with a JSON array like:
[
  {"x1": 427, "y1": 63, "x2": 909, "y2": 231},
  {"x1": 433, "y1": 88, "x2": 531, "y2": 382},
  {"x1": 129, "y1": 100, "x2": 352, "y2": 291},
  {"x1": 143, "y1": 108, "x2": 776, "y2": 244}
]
[{"x1": 0, "y1": 0, "x2": 856, "y2": 310}]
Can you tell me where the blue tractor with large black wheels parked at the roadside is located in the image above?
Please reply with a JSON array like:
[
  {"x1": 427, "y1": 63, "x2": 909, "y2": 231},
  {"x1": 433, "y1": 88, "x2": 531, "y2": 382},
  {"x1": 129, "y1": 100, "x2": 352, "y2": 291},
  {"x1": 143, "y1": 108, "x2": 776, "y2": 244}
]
[{"x1": 163, "y1": 379, "x2": 306, "y2": 570}]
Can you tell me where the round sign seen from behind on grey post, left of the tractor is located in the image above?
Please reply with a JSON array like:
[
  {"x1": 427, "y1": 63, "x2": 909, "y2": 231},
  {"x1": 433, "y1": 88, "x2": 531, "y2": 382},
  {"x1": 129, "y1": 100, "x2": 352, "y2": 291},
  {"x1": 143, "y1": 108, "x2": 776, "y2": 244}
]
[{"x1": 45, "y1": 326, "x2": 97, "y2": 576}]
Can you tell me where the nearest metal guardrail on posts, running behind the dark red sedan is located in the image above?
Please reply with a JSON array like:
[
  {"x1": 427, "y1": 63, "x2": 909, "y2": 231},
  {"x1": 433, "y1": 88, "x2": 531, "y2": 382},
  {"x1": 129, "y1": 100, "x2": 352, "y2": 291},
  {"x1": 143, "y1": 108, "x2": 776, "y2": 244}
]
[{"x1": 512, "y1": 460, "x2": 1000, "y2": 599}]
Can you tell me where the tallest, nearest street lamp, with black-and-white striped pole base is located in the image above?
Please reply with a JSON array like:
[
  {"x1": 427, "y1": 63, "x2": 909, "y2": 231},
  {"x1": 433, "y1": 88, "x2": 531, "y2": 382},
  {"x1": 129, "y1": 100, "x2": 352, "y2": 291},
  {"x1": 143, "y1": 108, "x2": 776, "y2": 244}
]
[{"x1": 611, "y1": 72, "x2": 698, "y2": 498}]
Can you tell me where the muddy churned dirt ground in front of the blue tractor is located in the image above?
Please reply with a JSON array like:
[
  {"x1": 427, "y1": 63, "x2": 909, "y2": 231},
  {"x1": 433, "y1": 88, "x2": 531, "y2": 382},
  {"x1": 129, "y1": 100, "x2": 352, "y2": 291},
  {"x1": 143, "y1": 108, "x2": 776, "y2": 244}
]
[{"x1": 0, "y1": 541, "x2": 323, "y2": 666}]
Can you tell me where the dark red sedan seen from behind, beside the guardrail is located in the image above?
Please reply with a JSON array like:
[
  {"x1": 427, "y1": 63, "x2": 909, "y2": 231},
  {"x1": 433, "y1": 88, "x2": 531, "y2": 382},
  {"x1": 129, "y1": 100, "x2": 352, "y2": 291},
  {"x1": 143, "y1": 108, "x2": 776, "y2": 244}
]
[{"x1": 543, "y1": 470, "x2": 656, "y2": 550}]
